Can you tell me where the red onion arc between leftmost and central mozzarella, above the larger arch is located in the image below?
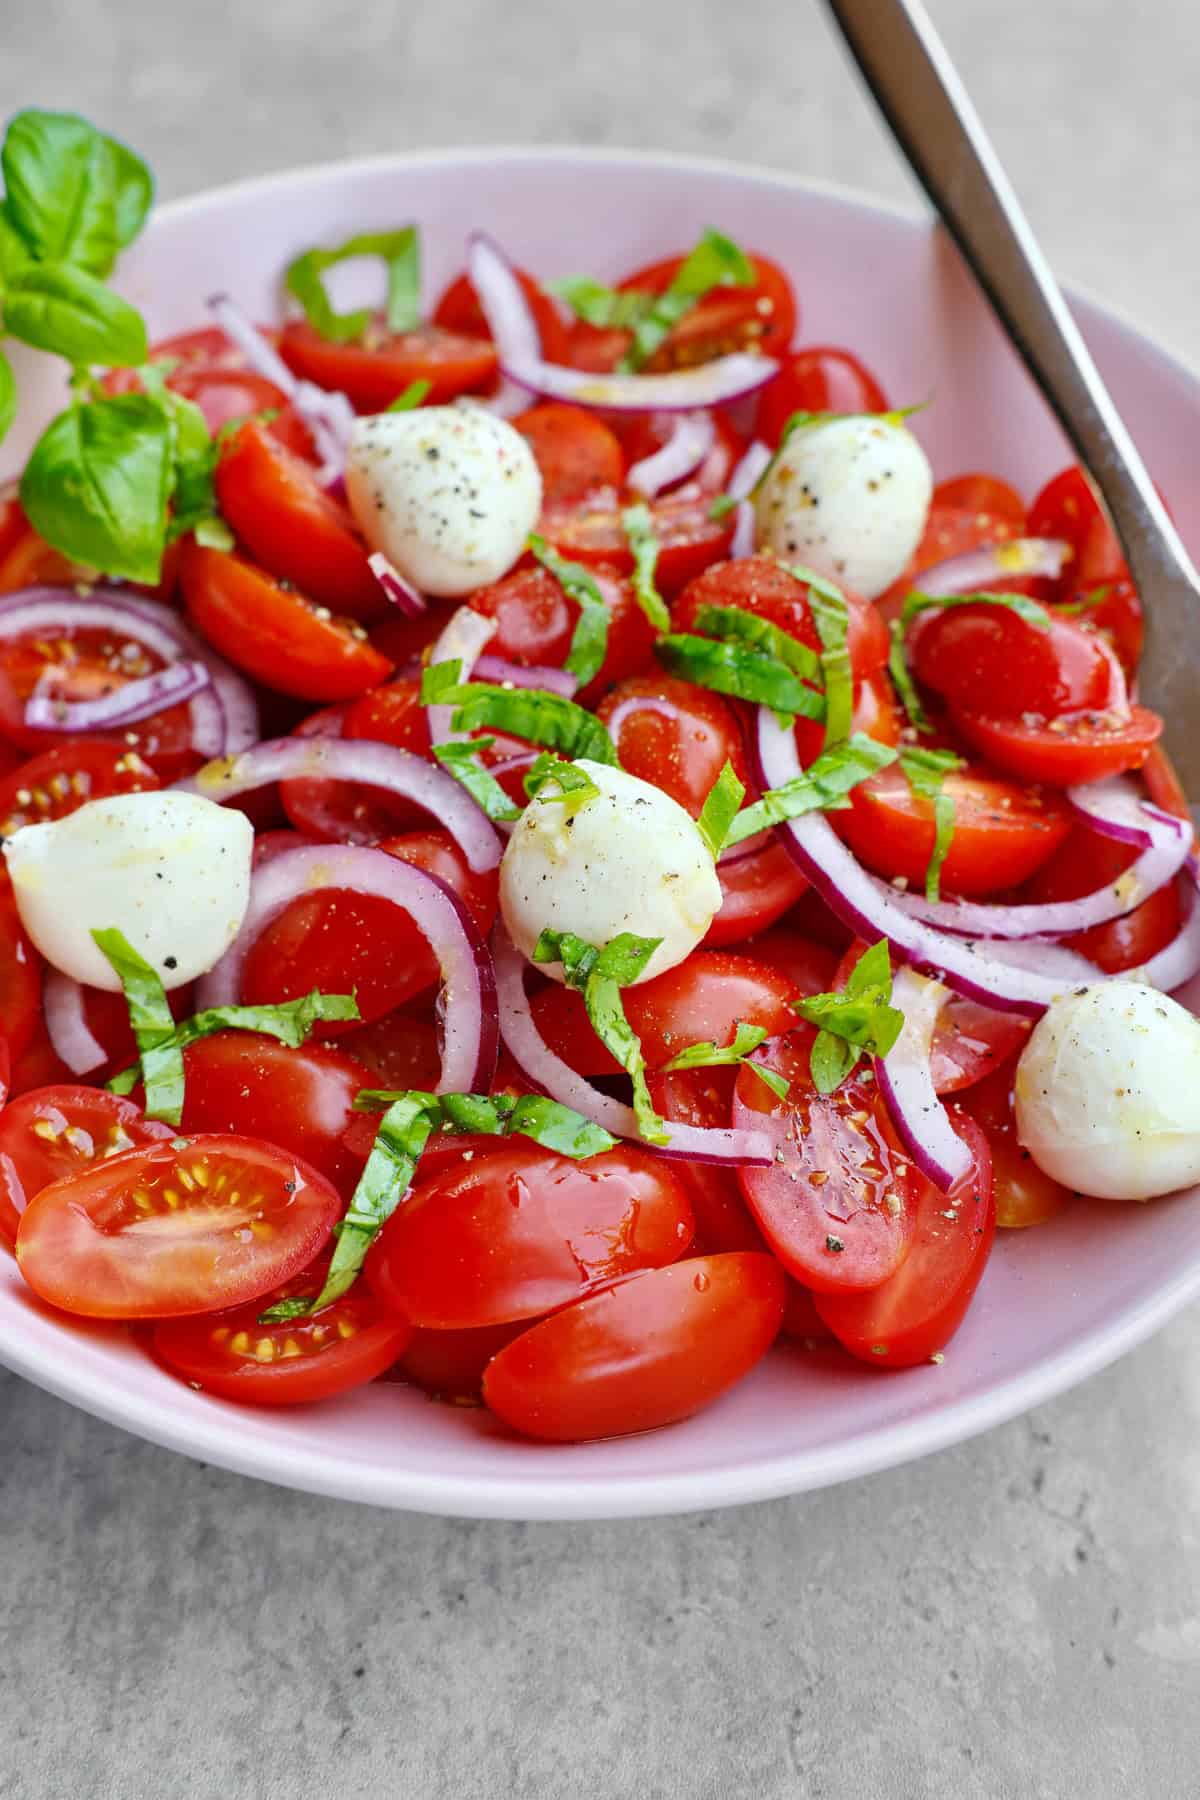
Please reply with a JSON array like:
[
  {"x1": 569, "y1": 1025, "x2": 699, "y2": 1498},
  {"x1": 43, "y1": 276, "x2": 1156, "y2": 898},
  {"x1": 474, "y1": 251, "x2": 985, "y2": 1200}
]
[{"x1": 176, "y1": 738, "x2": 500, "y2": 873}]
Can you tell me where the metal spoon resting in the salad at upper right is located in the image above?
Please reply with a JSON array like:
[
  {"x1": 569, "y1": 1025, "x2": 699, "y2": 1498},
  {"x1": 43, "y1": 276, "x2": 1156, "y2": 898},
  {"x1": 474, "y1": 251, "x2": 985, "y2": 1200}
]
[{"x1": 826, "y1": 0, "x2": 1200, "y2": 799}]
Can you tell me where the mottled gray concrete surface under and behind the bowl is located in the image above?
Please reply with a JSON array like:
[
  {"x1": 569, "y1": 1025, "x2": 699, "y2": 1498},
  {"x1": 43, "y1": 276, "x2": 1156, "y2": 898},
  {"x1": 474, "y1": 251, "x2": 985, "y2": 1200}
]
[{"x1": 0, "y1": 0, "x2": 1200, "y2": 1800}]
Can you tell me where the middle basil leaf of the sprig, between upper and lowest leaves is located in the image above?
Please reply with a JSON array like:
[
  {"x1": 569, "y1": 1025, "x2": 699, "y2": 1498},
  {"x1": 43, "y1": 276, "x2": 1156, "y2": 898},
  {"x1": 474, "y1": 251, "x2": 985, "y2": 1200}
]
[{"x1": 4, "y1": 263, "x2": 146, "y2": 367}]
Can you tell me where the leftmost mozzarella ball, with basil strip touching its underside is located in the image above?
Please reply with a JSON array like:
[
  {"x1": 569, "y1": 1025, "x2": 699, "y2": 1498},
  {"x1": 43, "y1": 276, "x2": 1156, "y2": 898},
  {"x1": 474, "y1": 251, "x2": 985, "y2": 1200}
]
[{"x1": 4, "y1": 790, "x2": 254, "y2": 992}]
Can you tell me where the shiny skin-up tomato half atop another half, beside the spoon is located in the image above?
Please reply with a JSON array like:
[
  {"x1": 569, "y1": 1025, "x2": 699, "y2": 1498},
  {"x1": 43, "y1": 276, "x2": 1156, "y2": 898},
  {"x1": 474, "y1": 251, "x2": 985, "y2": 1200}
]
[{"x1": 909, "y1": 603, "x2": 1124, "y2": 718}]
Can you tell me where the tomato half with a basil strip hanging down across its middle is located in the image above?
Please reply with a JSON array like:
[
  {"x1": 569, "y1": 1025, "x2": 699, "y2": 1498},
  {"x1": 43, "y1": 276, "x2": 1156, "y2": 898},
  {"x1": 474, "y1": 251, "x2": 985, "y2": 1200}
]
[{"x1": 829, "y1": 765, "x2": 1070, "y2": 895}]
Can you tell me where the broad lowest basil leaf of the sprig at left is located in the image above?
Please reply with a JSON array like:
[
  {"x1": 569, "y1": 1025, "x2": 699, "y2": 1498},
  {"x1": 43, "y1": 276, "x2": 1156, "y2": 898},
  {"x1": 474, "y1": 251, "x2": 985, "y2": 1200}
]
[{"x1": 20, "y1": 394, "x2": 173, "y2": 583}]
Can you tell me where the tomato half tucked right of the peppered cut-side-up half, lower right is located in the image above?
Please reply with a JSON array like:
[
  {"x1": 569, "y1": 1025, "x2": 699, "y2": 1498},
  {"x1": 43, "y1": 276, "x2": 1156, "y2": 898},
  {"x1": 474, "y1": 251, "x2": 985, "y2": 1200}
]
[{"x1": 815, "y1": 1112, "x2": 997, "y2": 1368}]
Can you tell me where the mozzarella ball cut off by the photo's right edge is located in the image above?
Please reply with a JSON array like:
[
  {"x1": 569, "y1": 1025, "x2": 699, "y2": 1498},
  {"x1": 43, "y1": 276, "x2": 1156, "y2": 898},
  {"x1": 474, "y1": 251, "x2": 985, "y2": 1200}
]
[{"x1": 1016, "y1": 981, "x2": 1200, "y2": 1201}]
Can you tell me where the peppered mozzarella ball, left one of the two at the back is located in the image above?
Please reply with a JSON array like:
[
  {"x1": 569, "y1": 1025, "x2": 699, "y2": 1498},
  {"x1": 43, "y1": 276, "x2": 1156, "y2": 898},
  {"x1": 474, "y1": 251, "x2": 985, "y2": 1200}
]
[{"x1": 345, "y1": 407, "x2": 542, "y2": 594}]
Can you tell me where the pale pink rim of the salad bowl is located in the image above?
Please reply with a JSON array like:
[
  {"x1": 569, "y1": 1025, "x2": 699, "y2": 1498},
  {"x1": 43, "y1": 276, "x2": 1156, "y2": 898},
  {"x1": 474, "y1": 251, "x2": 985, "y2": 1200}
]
[{"x1": 0, "y1": 144, "x2": 1200, "y2": 1519}]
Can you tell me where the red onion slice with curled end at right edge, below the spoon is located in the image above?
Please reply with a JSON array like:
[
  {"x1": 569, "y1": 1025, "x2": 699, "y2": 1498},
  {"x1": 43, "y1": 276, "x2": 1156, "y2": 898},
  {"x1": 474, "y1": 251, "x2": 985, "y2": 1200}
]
[{"x1": 876, "y1": 778, "x2": 1193, "y2": 938}]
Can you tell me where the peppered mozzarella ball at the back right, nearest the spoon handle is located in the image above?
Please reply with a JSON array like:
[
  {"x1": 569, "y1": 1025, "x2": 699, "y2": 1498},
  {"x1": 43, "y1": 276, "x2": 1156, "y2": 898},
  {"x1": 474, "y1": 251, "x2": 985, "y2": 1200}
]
[{"x1": 756, "y1": 416, "x2": 934, "y2": 599}]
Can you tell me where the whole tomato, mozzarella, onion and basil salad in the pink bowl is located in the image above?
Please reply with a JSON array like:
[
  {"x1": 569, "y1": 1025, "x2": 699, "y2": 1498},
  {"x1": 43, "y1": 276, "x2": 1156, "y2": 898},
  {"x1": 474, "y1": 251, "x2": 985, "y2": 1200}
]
[{"x1": 0, "y1": 112, "x2": 1200, "y2": 1440}]
